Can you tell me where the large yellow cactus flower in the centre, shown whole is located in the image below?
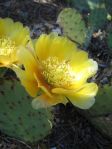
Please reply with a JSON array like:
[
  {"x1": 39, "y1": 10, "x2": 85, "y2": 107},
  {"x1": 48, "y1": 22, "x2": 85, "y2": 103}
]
[{"x1": 14, "y1": 34, "x2": 98, "y2": 109}]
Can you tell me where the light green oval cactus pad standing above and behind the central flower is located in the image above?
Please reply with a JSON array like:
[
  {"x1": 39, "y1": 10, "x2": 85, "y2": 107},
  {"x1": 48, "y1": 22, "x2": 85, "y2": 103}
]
[{"x1": 57, "y1": 8, "x2": 86, "y2": 44}]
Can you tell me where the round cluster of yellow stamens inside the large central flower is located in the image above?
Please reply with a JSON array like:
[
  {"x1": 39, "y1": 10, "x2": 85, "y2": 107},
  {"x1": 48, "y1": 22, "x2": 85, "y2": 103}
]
[{"x1": 42, "y1": 57, "x2": 75, "y2": 88}]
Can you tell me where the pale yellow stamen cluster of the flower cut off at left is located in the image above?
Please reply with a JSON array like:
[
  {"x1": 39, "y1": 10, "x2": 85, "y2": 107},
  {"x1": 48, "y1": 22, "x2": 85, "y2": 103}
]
[{"x1": 0, "y1": 37, "x2": 15, "y2": 55}]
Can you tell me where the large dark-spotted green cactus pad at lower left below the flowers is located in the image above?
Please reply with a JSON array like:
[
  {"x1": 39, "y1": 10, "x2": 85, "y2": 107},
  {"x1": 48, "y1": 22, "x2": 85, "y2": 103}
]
[{"x1": 0, "y1": 80, "x2": 52, "y2": 142}]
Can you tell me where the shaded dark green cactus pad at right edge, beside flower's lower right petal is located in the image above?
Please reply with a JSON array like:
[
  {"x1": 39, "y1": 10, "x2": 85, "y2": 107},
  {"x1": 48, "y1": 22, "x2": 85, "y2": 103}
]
[{"x1": 89, "y1": 85, "x2": 112, "y2": 117}]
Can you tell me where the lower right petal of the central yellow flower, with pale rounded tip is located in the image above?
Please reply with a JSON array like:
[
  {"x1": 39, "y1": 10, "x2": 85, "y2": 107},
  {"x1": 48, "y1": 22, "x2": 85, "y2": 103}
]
[{"x1": 52, "y1": 83, "x2": 98, "y2": 109}]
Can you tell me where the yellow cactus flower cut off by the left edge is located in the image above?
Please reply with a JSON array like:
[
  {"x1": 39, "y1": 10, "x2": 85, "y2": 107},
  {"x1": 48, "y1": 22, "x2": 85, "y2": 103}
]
[{"x1": 0, "y1": 18, "x2": 30, "y2": 67}]
